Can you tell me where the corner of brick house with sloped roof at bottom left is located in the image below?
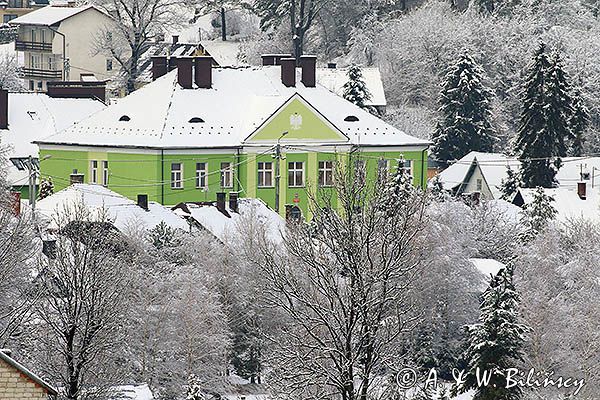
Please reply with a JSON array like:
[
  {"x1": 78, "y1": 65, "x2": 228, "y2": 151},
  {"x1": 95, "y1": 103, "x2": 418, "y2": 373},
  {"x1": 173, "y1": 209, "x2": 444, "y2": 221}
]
[{"x1": 0, "y1": 349, "x2": 58, "y2": 400}]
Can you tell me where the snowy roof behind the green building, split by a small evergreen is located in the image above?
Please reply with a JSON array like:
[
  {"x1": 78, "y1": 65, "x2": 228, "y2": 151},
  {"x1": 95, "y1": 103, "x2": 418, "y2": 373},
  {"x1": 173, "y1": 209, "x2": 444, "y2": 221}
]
[{"x1": 317, "y1": 68, "x2": 387, "y2": 106}]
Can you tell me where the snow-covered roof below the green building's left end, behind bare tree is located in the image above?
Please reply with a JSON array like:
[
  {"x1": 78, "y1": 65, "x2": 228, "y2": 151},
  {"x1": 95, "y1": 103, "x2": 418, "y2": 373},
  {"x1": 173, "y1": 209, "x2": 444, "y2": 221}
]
[{"x1": 36, "y1": 183, "x2": 189, "y2": 230}]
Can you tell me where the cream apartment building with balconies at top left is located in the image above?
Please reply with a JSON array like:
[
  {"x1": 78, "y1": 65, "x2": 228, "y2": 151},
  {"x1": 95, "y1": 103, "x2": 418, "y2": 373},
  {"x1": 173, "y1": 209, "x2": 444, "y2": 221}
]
[{"x1": 10, "y1": 5, "x2": 117, "y2": 91}]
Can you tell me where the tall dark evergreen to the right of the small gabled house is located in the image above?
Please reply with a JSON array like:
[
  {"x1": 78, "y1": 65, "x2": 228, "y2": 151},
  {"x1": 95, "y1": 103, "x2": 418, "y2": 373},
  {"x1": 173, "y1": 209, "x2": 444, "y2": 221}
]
[{"x1": 516, "y1": 43, "x2": 573, "y2": 188}]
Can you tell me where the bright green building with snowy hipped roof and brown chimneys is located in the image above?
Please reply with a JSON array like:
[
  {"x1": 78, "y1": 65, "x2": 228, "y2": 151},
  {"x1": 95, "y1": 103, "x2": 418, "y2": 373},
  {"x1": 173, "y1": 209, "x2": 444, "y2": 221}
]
[{"x1": 37, "y1": 56, "x2": 429, "y2": 219}]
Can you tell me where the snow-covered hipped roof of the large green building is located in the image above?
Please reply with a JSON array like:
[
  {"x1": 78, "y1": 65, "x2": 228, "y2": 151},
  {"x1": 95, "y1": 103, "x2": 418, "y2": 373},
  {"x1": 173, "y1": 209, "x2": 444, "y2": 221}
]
[{"x1": 39, "y1": 66, "x2": 429, "y2": 148}]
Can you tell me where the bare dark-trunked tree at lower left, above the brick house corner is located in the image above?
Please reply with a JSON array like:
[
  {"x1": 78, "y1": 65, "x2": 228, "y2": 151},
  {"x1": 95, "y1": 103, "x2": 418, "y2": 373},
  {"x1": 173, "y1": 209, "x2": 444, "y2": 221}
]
[{"x1": 35, "y1": 204, "x2": 128, "y2": 400}]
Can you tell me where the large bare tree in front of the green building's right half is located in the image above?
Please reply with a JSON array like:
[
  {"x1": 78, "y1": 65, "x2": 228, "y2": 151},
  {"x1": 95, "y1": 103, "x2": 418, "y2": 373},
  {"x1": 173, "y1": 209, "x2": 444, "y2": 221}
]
[{"x1": 247, "y1": 159, "x2": 425, "y2": 400}]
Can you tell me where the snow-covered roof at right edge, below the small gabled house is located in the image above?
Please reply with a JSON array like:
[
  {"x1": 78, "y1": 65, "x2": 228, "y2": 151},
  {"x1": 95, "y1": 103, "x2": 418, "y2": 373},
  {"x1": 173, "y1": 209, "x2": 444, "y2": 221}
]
[{"x1": 519, "y1": 185, "x2": 600, "y2": 222}]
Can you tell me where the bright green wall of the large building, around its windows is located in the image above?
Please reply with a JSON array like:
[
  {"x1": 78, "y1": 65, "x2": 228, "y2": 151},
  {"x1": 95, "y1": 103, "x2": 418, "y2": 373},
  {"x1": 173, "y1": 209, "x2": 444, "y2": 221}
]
[{"x1": 40, "y1": 146, "x2": 427, "y2": 217}]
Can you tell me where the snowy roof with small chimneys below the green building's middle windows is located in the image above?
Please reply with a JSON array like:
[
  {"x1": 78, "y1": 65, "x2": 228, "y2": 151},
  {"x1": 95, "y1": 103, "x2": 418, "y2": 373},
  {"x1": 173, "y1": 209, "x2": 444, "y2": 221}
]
[{"x1": 174, "y1": 198, "x2": 285, "y2": 243}]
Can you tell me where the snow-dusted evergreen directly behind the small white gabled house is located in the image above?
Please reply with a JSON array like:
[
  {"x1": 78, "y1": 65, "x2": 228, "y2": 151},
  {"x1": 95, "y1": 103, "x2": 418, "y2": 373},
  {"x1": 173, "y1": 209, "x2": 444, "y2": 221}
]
[{"x1": 432, "y1": 52, "x2": 495, "y2": 167}]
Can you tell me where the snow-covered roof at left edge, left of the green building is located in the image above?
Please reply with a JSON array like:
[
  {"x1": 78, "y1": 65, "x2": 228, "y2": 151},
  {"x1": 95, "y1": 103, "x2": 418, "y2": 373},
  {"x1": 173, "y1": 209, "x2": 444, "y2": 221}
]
[{"x1": 0, "y1": 93, "x2": 105, "y2": 184}]
